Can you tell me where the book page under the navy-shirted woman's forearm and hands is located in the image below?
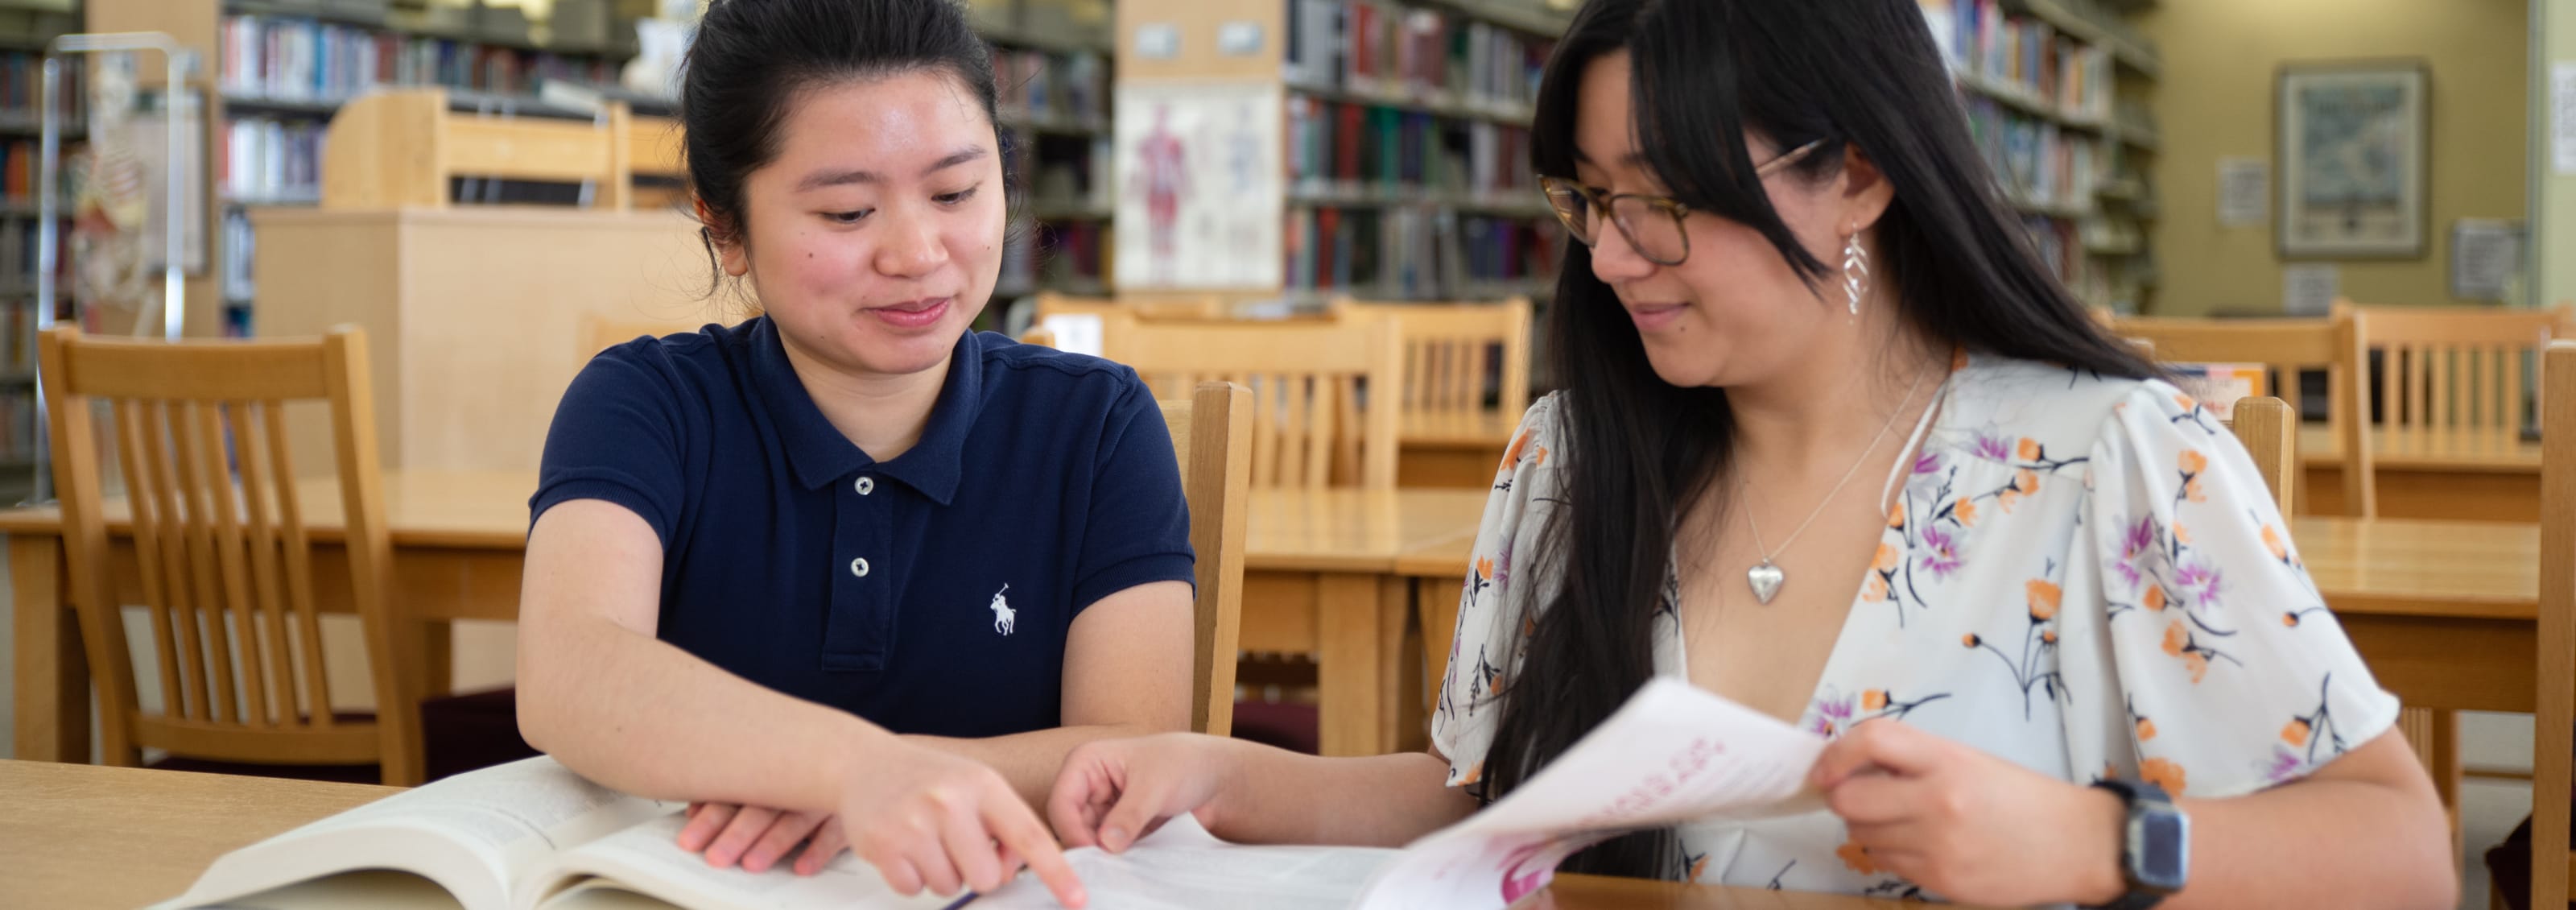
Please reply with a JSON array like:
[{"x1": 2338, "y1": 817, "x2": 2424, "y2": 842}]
[{"x1": 515, "y1": 815, "x2": 958, "y2": 910}]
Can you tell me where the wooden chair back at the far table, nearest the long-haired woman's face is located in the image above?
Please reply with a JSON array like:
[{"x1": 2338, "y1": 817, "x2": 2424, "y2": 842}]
[{"x1": 1331, "y1": 296, "x2": 1530, "y2": 420}]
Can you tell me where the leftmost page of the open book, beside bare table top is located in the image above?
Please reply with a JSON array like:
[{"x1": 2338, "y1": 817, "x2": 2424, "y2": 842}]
[{"x1": 163, "y1": 755, "x2": 680, "y2": 910}]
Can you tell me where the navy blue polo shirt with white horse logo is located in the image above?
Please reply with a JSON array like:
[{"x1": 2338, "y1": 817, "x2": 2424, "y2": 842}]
[{"x1": 528, "y1": 317, "x2": 1193, "y2": 738}]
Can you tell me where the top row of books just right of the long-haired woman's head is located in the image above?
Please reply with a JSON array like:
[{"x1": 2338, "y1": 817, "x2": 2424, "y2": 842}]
[{"x1": 1922, "y1": 0, "x2": 2112, "y2": 121}]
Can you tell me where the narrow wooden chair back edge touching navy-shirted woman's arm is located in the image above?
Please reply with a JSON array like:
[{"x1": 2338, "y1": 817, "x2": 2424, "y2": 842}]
[{"x1": 1162, "y1": 382, "x2": 1252, "y2": 738}]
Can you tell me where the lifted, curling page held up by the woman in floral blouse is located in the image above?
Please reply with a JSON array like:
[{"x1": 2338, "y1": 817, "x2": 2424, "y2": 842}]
[{"x1": 1355, "y1": 678, "x2": 1824, "y2": 910}]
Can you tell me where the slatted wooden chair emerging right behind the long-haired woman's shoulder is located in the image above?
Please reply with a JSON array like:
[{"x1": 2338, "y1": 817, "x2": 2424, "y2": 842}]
[{"x1": 2110, "y1": 317, "x2": 2378, "y2": 510}]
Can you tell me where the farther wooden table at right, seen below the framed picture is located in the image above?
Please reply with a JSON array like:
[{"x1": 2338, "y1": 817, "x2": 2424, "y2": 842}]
[{"x1": 2297, "y1": 423, "x2": 2540, "y2": 523}]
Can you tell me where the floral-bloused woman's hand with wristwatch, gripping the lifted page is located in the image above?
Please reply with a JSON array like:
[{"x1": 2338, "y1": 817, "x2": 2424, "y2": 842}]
[{"x1": 1808, "y1": 719, "x2": 2128, "y2": 908}]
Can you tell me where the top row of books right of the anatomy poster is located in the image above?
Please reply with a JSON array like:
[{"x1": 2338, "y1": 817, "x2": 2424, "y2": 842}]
[{"x1": 1283, "y1": 0, "x2": 1554, "y2": 111}]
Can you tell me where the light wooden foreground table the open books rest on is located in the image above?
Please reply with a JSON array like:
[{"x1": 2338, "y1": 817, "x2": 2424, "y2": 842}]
[{"x1": 0, "y1": 760, "x2": 1909, "y2": 910}]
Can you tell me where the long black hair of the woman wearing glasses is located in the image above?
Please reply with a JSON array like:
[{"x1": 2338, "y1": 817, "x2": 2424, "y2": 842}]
[{"x1": 1484, "y1": 0, "x2": 2151, "y2": 879}]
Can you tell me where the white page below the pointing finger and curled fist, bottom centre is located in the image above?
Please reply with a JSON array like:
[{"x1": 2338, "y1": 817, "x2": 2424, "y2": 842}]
[{"x1": 968, "y1": 815, "x2": 1396, "y2": 910}]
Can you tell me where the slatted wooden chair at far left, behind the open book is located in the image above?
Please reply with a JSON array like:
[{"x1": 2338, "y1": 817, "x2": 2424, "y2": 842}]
[{"x1": 36, "y1": 328, "x2": 425, "y2": 784}]
